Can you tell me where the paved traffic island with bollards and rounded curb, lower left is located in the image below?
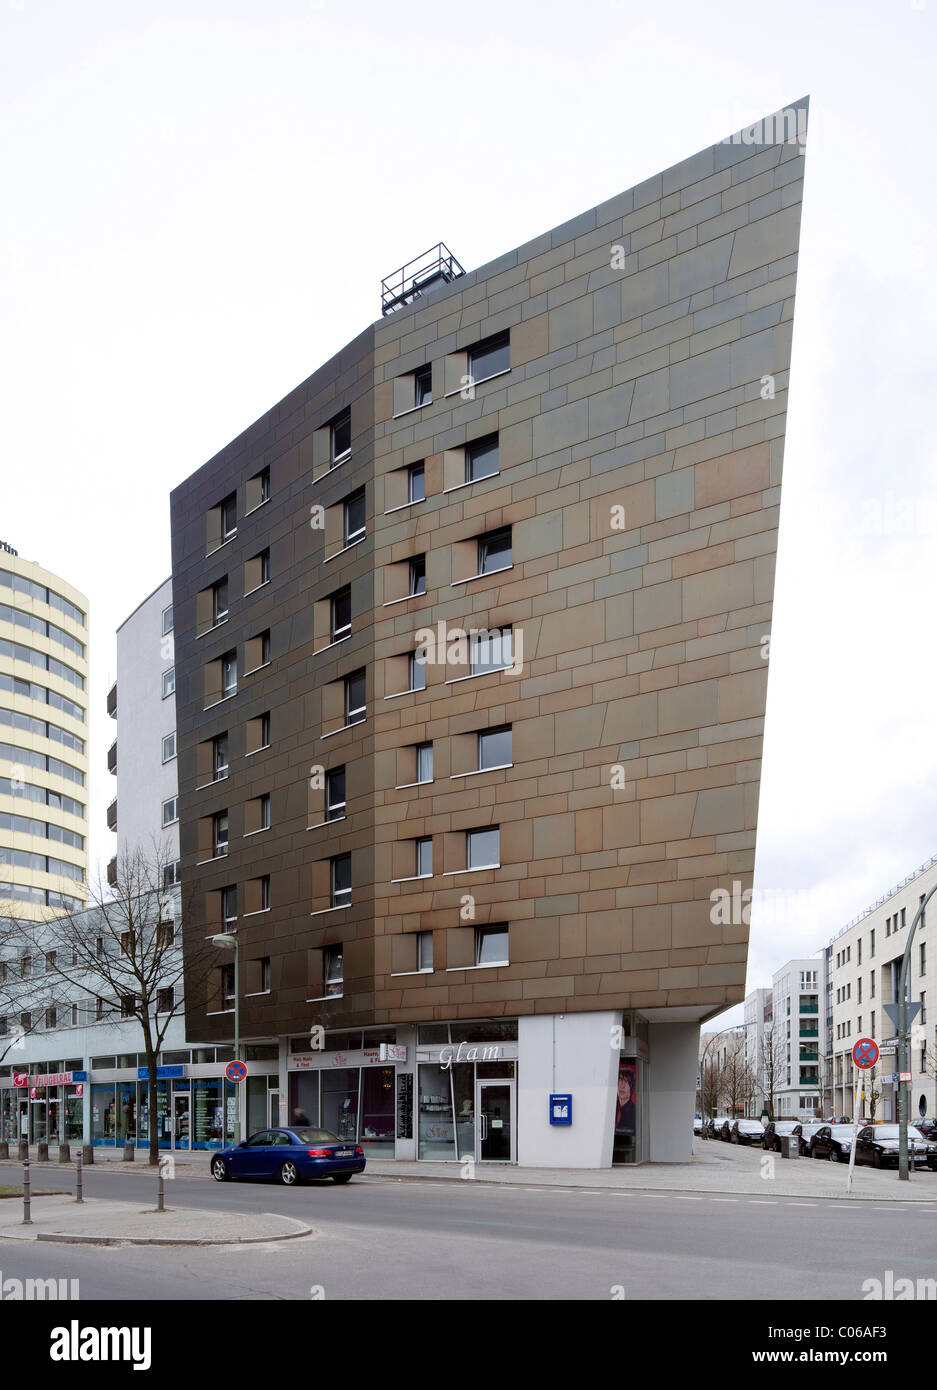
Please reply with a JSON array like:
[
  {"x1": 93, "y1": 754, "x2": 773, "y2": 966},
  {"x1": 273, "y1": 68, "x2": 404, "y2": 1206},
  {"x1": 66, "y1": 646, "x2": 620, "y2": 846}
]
[{"x1": 0, "y1": 1195, "x2": 316, "y2": 1245}]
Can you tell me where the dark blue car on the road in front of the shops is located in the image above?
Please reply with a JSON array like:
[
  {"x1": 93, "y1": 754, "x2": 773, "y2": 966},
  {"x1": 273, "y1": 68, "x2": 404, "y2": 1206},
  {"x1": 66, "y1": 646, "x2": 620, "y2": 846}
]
[{"x1": 211, "y1": 1127, "x2": 366, "y2": 1187}]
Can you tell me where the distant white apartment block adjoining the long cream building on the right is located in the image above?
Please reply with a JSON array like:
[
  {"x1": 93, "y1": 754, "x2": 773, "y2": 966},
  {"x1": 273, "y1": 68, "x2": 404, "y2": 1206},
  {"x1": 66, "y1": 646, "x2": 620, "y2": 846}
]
[{"x1": 772, "y1": 955, "x2": 826, "y2": 1120}]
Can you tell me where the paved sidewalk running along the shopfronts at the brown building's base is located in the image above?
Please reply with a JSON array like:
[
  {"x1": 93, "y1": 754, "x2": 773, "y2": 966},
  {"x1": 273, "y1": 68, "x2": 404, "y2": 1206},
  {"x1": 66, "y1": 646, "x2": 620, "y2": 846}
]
[{"x1": 0, "y1": 1140, "x2": 937, "y2": 1205}]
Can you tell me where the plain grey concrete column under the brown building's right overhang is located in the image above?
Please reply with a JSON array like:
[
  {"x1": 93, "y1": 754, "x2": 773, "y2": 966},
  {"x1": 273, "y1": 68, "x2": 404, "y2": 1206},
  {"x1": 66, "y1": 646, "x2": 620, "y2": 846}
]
[{"x1": 646, "y1": 1023, "x2": 699, "y2": 1163}]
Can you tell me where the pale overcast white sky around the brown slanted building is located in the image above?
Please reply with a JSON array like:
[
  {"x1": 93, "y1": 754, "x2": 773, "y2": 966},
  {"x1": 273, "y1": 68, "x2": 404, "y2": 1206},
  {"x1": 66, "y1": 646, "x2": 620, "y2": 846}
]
[{"x1": 0, "y1": 0, "x2": 937, "y2": 1023}]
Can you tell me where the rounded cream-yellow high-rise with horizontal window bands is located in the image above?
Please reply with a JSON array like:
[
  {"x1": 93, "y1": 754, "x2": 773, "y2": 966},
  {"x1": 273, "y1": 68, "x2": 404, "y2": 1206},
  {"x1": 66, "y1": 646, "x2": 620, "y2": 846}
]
[{"x1": 0, "y1": 542, "x2": 88, "y2": 920}]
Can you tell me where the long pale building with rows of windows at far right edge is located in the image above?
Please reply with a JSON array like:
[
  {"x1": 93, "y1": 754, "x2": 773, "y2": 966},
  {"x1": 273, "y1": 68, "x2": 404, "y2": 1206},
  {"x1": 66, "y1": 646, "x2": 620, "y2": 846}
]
[{"x1": 829, "y1": 856, "x2": 937, "y2": 1122}]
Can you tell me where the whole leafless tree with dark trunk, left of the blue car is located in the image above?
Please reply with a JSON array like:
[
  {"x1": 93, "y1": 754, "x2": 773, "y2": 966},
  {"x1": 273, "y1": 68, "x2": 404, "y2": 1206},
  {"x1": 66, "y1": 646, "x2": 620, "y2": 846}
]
[{"x1": 4, "y1": 845, "x2": 208, "y2": 1165}]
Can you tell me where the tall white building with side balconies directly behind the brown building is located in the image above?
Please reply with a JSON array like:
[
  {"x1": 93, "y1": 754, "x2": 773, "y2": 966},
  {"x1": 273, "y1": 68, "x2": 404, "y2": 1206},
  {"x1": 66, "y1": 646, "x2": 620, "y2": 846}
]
[{"x1": 107, "y1": 578, "x2": 179, "y2": 884}]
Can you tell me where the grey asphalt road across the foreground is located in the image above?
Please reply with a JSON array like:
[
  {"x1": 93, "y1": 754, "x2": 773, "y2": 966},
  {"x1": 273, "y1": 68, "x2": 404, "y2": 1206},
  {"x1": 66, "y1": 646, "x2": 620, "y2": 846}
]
[{"x1": 0, "y1": 1170, "x2": 937, "y2": 1301}]
